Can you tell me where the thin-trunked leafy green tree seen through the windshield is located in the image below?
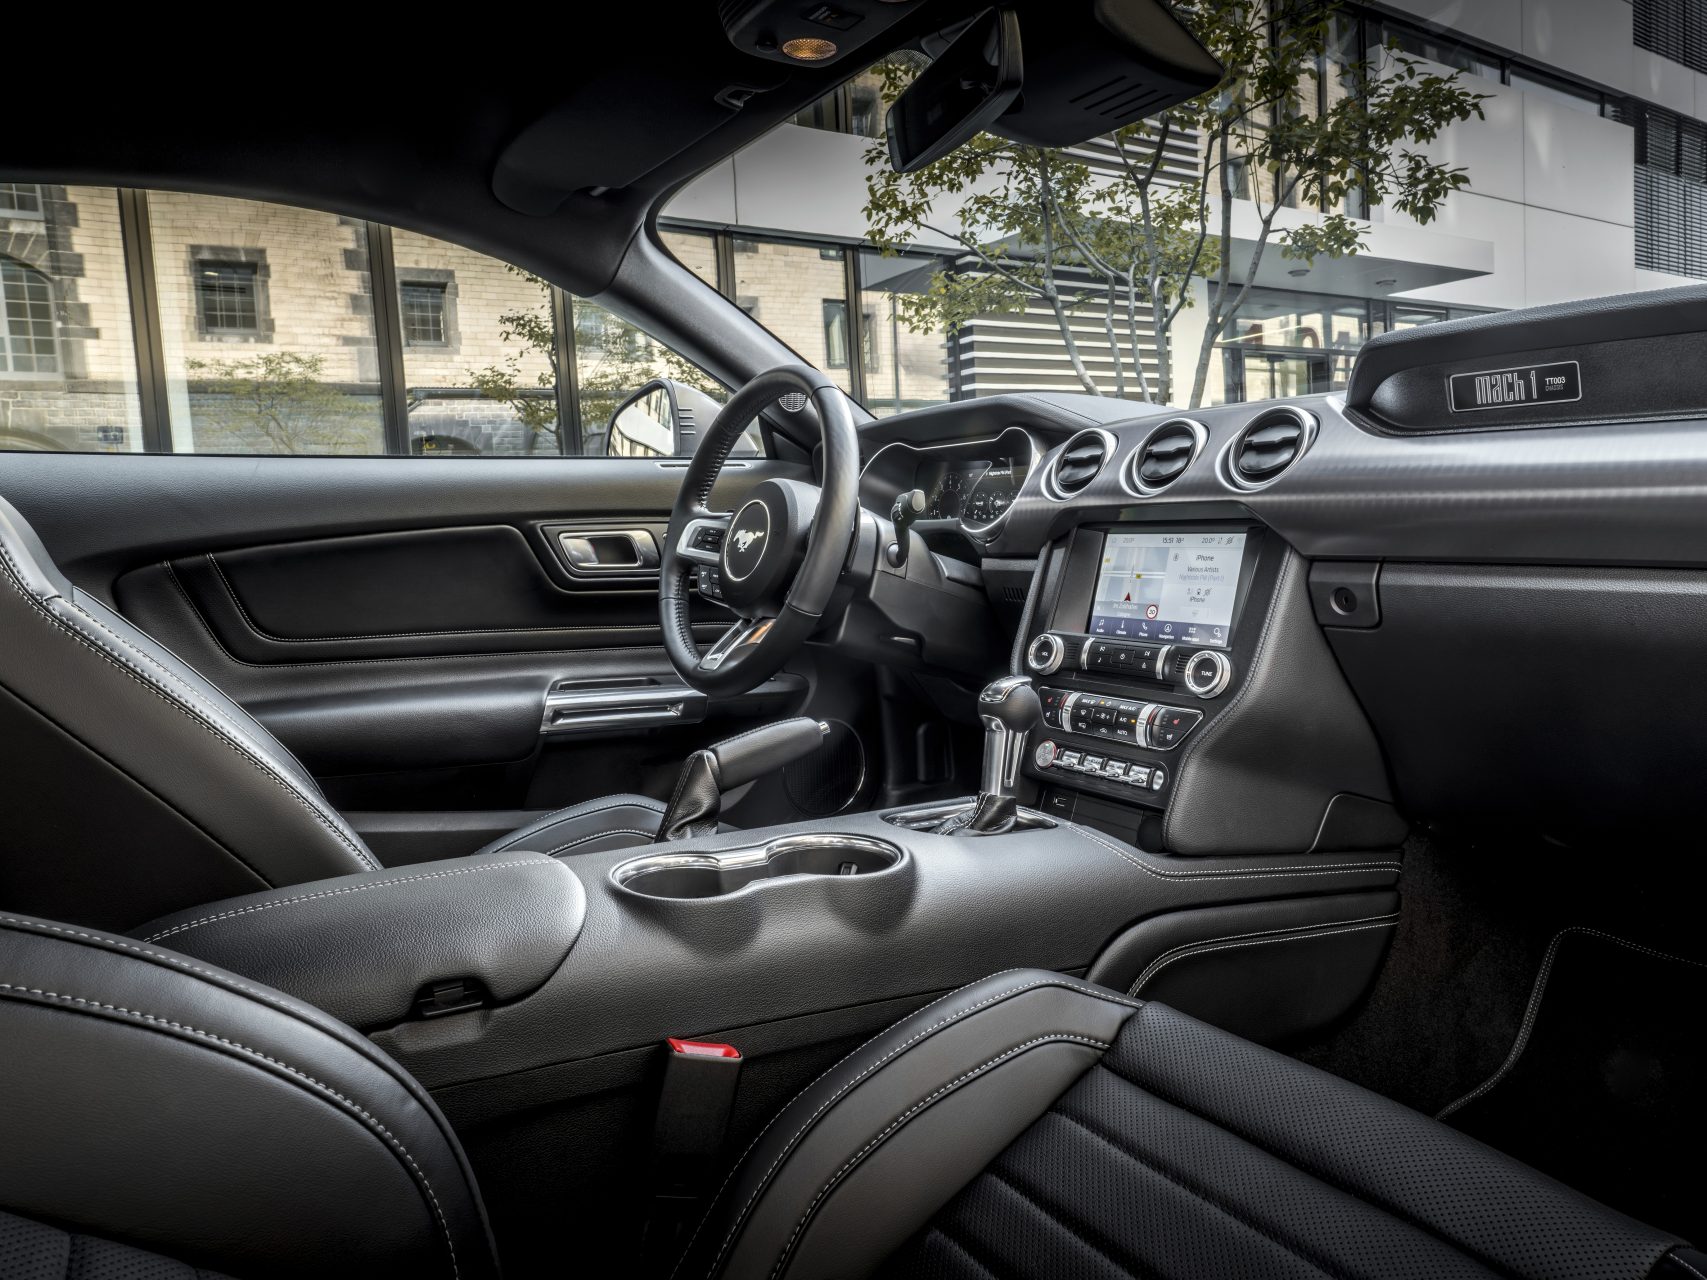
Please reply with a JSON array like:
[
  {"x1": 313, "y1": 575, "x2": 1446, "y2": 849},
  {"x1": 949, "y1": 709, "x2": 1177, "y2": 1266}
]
[{"x1": 865, "y1": 0, "x2": 1483, "y2": 406}]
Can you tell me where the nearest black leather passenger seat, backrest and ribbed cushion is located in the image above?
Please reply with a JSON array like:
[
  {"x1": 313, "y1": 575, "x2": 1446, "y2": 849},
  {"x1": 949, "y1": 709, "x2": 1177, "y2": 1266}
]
[{"x1": 0, "y1": 935, "x2": 1707, "y2": 1280}]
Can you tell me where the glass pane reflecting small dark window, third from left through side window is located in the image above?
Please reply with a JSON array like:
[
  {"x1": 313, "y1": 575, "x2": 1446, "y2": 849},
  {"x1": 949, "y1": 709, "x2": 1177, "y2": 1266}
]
[{"x1": 391, "y1": 229, "x2": 572, "y2": 457}]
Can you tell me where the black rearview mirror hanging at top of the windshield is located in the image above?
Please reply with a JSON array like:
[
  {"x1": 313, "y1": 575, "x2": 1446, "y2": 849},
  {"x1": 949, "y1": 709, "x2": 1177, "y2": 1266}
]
[{"x1": 888, "y1": 9, "x2": 1024, "y2": 174}]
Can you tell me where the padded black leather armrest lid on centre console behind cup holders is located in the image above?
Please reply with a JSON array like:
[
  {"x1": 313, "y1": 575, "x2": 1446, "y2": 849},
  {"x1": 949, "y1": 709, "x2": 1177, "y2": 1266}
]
[{"x1": 133, "y1": 852, "x2": 587, "y2": 1027}]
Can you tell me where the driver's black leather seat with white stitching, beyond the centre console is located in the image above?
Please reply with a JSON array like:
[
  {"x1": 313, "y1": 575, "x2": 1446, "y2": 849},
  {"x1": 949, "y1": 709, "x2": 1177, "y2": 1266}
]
[{"x1": 0, "y1": 500, "x2": 662, "y2": 928}]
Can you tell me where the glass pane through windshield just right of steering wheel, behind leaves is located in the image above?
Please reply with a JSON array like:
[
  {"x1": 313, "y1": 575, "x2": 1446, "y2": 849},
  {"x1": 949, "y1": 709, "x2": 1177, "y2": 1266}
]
[{"x1": 859, "y1": 249, "x2": 951, "y2": 416}]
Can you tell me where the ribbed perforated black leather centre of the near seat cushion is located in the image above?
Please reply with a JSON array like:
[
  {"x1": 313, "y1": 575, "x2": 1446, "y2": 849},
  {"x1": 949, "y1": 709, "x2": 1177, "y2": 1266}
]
[{"x1": 880, "y1": 1004, "x2": 1678, "y2": 1280}]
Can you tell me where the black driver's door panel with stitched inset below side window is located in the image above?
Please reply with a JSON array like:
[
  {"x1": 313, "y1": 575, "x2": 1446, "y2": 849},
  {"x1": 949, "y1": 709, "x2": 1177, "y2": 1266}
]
[{"x1": 0, "y1": 454, "x2": 816, "y2": 822}]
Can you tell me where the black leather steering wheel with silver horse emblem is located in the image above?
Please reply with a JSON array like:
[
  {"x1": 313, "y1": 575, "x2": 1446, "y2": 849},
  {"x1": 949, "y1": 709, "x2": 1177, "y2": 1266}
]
[{"x1": 659, "y1": 365, "x2": 859, "y2": 696}]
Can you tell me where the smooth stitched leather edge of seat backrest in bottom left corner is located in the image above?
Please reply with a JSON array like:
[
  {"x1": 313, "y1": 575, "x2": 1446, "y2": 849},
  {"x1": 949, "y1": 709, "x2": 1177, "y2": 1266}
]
[{"x1": 0, "y1": 916, "x2": 497, "y2": 1280}]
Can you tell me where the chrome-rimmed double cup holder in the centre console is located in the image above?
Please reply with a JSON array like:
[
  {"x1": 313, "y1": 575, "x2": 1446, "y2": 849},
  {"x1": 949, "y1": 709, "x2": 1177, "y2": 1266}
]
[{"x1": 611, "y1": 835, "x2": 906, "y2": 898}]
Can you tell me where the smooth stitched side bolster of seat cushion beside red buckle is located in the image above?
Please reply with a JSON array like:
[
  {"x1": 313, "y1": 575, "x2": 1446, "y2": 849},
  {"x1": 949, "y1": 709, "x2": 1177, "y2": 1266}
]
[{"x1": 674, "y1": 969, "x2": 1140, "y2": 1277}]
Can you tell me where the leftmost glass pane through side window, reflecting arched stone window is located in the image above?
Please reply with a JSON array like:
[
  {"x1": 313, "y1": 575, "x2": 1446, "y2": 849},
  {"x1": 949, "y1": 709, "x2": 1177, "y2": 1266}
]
[{"x1": 0, "y1": 183, "x2": 143, "y2": 452}]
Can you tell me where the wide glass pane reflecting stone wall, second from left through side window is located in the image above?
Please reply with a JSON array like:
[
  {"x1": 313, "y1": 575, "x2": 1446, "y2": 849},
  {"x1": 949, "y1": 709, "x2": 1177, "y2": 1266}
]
[{"x1": 147, "y1": 191, "x2": 384, "y2": 454}]
